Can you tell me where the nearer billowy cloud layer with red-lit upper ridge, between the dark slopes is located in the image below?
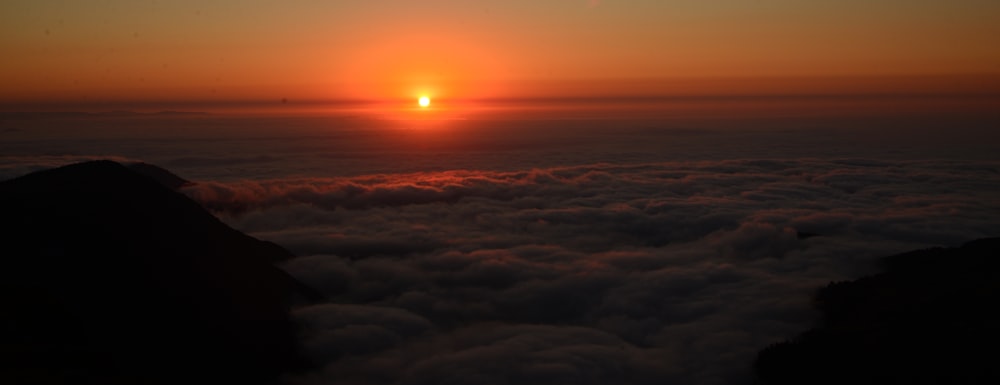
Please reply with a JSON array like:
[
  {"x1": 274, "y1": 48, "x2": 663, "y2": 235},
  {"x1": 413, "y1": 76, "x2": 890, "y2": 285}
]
[{"x1": 184, "y1": 159, "x2": 1000, "y2": 384}]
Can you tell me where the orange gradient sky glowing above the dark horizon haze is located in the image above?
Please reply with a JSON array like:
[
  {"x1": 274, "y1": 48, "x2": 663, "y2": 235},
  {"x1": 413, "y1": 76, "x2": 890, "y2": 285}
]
[{"x1": 0, "y1": 0, "x2": 1000, "y2": 101}]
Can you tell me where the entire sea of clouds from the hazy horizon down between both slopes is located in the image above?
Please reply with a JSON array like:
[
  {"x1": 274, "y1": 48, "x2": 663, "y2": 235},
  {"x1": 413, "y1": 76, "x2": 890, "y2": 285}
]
[{"x1": 0, "y1": 110, "x2": 1000, "y2": 384}]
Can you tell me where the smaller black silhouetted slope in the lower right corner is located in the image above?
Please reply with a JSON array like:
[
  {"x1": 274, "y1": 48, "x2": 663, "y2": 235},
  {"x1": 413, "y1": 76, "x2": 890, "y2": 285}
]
[{"x1": 756, "y1": 238, "x2": 1000, "y2": 385}]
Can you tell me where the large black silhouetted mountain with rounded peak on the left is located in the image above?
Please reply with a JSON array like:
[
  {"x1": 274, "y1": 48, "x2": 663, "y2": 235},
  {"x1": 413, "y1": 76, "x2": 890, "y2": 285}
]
[{"x1": 0, "y1": 161, "x2": 308, "y2": 384}]
